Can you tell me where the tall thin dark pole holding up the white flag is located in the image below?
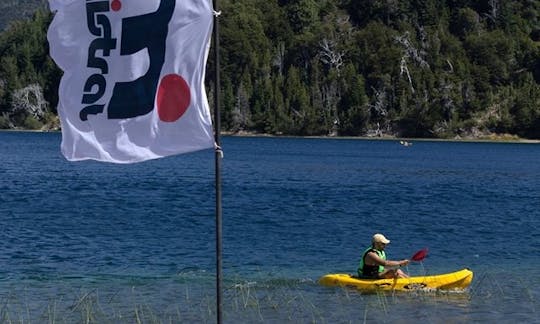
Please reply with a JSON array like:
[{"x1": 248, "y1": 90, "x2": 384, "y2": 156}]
[{"x1": 212, "y1": 0, "x2": 223, "y2": 324}]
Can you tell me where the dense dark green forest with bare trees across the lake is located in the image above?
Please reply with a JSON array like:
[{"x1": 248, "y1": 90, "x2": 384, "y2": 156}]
[{"x1": 0, "y1": 0, "x2": 540, "y2": 139}]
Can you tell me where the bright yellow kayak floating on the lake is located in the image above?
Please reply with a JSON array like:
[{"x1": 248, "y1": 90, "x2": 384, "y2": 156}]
[{"x1": 319, "y1": 269, "x2": 473, "y2": 291}]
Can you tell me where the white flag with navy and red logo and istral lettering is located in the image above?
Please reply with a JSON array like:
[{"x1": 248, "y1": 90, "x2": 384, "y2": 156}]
[{"x1": 47, "y1": 0, "x2": 214, "y2": 163}]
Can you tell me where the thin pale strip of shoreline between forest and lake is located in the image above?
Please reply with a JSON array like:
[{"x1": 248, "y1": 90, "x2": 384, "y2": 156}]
[{"x1": 0, "y1": 129, "x2": 540, "y2": 144}]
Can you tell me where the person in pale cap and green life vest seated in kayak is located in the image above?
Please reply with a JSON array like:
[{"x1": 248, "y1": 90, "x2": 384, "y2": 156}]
[{"x1": 358, "y1": 233, "x2": 409, "y2": 279}]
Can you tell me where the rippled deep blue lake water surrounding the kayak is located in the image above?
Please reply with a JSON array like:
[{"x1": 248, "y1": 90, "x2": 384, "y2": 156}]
[{"x1": 0, "y1": 132, "x2": 540, "y2": 323}]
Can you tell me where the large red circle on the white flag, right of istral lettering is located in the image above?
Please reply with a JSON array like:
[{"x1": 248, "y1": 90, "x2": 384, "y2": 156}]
[{"x1": 156, "y1": 74, "x2": 191, "y2": 123}]
